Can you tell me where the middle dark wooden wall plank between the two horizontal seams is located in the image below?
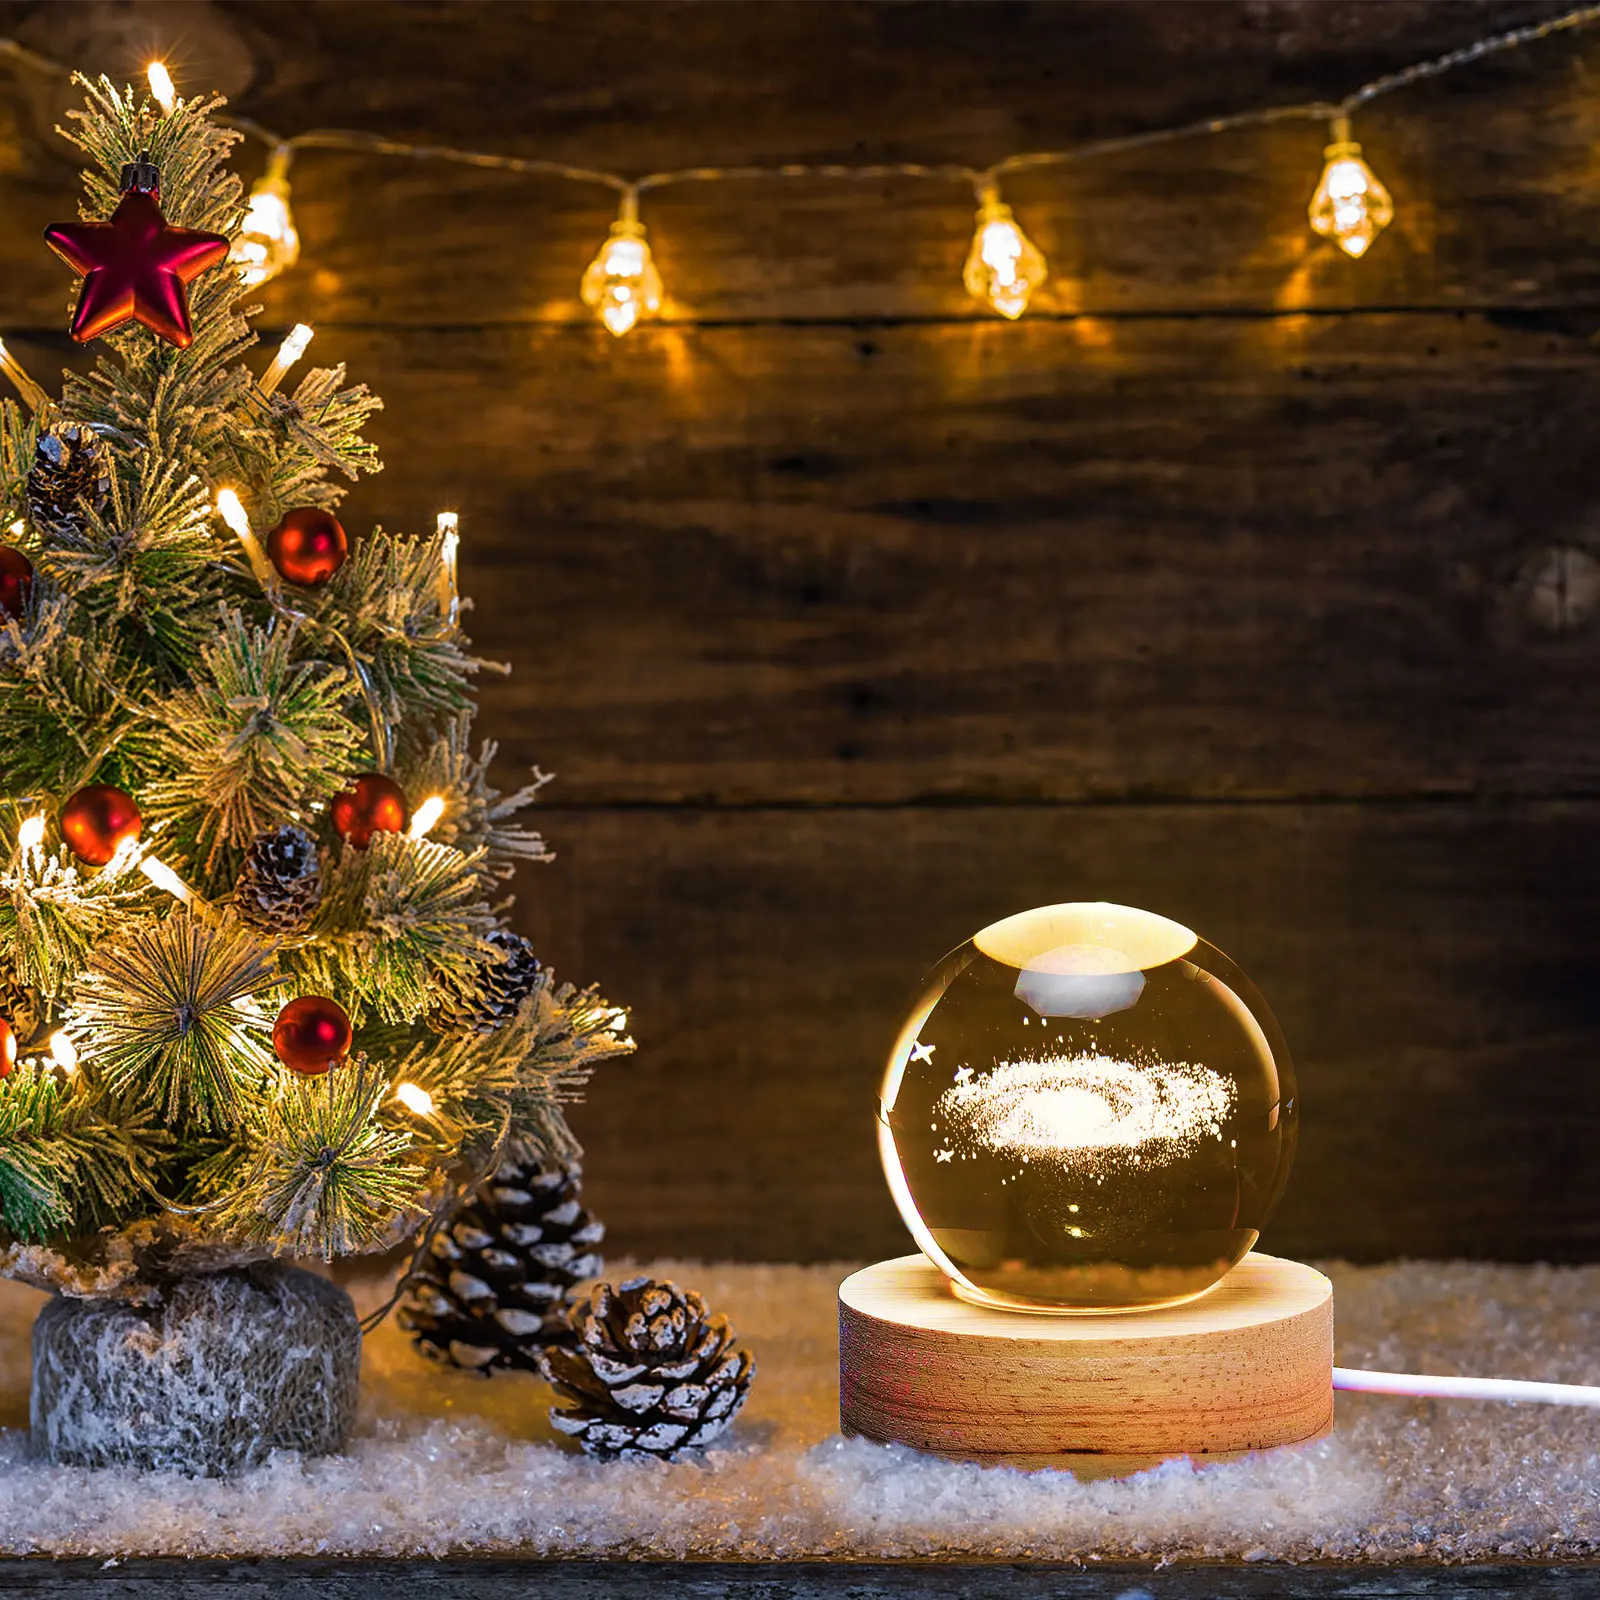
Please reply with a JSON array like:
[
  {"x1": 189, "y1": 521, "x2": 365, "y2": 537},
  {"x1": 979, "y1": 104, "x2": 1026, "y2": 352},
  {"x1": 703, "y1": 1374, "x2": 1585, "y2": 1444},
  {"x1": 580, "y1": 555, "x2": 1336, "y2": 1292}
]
[{"x1": 12, "y1": 315, "x2": 1600, "y2": 805}]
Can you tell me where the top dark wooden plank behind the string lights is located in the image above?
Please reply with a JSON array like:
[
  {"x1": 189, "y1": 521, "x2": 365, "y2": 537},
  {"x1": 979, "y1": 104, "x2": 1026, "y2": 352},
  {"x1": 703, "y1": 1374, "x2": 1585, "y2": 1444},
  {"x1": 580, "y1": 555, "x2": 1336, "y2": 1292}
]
[{"x1": 0, "y1": 0, "x2": 1600, "y2": 326}]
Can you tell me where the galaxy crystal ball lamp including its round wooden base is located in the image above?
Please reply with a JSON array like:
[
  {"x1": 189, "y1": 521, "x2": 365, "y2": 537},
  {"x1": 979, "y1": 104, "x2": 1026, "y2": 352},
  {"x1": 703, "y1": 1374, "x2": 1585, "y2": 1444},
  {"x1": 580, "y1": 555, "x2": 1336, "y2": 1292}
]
[{"x1": 838, "y1": 902, "x2": 1334, "y2": 1477}]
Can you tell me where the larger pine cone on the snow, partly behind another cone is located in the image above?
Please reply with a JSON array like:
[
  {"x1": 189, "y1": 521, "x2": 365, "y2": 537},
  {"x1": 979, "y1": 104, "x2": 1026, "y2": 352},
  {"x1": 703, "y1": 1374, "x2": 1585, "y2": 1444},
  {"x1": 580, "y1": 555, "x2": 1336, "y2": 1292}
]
[{"x1": 398, "y1": 1160, "x2": 605, "y2": 1378}]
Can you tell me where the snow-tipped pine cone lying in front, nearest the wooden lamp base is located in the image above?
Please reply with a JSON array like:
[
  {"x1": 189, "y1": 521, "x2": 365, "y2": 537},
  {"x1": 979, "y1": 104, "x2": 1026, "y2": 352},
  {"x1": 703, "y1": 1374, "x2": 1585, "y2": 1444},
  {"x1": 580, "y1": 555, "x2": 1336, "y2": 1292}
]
[{"x1": 541, "y1": 1278, "x2": 755, "y2": 1461}]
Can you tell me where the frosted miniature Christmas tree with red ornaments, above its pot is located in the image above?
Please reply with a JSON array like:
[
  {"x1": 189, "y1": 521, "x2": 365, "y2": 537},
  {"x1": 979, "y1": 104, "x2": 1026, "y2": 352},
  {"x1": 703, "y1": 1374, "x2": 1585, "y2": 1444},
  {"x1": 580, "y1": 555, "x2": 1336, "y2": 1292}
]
[{"x1": 0, "y1": 80, "x2": 632, "y2": 1296}]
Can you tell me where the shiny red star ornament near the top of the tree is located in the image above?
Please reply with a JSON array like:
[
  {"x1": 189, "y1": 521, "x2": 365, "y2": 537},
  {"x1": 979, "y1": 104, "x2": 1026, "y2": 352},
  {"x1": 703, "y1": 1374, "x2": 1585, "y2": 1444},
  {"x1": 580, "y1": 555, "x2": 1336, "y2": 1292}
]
[{"x1": 45, "y1": 152, "x2": 227, "y2": 350}]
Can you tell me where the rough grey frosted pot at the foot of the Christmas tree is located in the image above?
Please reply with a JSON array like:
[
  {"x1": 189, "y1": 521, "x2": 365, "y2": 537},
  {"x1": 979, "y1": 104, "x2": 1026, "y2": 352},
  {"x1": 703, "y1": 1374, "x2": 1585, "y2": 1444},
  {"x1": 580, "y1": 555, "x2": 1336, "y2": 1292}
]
[{"x1": 30, "y1": 1262, "x2": 362, "y2": 1477}]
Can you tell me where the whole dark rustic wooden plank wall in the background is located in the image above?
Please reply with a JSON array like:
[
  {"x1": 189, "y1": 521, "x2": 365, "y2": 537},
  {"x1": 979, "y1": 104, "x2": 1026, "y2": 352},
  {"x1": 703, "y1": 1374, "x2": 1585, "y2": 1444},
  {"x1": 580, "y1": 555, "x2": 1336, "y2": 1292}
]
[{"x1": 0, "y1": 0, "x2": 1600, "y2": 1259}]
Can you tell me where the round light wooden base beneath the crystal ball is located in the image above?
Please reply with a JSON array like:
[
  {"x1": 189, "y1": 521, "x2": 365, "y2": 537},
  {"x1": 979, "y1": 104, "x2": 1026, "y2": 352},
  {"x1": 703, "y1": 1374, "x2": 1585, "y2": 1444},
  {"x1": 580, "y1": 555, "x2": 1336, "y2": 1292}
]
[{"x1": 838, "y1": 1254, "x2": 1333, "y2": 1478}]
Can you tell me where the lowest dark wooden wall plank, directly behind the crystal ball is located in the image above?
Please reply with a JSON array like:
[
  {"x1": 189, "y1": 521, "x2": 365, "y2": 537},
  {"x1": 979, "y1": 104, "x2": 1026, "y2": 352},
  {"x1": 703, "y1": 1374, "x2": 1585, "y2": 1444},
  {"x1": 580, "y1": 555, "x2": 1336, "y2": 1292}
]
[{"x1": 522, "y1": 802, "x2": 1600, "y2": 1261}]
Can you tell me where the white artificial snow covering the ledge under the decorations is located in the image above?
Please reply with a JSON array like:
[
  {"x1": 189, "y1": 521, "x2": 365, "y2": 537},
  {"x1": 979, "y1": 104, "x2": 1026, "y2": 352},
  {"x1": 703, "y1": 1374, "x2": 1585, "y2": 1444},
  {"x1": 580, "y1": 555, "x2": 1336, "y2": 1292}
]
[{"x1": 0, "y1": 1262, "x2": 1600, "y2": 1562}]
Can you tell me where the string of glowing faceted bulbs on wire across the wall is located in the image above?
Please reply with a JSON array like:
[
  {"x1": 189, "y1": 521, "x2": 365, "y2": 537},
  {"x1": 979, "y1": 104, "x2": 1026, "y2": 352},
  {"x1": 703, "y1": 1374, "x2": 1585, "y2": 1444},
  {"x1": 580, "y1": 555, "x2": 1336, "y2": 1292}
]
[{"x1": 0, "y1": 3, "x2": 1600, "y2": 334}]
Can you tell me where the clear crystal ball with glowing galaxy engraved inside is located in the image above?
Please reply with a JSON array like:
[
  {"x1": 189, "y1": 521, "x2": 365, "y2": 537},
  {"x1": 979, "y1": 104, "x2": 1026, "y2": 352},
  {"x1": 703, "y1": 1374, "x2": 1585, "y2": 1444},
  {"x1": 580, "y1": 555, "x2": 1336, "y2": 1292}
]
[{"x1": 878, "y1": 902, "x2": 1298, "y2": 1312}]
